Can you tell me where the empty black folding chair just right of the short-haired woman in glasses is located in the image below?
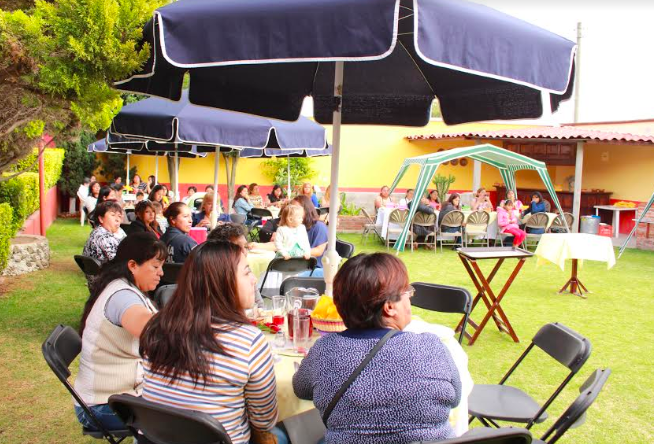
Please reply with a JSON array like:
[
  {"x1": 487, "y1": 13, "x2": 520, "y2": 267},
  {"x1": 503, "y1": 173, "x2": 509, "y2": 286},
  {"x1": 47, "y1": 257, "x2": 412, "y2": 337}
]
[{"x1": 411, "y1": 282, "x2": 472, "y2": 344}]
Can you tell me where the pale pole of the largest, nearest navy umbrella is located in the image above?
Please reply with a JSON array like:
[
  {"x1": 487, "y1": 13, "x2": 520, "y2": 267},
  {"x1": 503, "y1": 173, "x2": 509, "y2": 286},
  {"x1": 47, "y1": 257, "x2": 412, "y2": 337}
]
[{"x1": 322, "y1": 62, "x2": 343, "y2": 296}]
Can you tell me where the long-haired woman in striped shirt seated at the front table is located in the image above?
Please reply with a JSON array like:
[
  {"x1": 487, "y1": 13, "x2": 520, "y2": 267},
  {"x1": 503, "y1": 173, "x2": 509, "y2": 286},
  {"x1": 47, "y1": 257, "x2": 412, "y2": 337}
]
[{"x1": 140, "y1": 242, "x2": 285, "y2": 444}]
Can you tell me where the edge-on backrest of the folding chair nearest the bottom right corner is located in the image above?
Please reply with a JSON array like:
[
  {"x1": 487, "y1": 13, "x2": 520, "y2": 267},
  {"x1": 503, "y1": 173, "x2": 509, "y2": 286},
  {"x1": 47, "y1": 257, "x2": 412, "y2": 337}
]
[{"x1": 541, "y1": 368, "x2": 611, "y2": 444}]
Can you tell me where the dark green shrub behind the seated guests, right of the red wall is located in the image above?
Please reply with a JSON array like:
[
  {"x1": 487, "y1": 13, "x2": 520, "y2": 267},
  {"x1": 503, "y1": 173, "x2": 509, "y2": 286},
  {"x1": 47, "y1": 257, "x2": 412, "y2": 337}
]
[{"x1": 57, "y1": 132, "x2": 99, "y2": 196}]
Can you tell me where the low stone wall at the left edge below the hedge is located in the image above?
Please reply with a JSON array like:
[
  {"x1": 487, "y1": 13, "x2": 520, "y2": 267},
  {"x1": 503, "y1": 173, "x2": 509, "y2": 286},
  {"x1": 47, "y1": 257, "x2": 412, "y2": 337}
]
[{"x1": 2, "y1": 234, "x2": 50, "y2": 276}]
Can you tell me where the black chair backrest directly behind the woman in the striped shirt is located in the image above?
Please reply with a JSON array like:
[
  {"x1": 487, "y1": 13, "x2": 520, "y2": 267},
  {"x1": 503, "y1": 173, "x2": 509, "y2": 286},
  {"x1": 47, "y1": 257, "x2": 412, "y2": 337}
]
[{"x1": 109, "y1": 395, "x2": 232, "y2": 444}]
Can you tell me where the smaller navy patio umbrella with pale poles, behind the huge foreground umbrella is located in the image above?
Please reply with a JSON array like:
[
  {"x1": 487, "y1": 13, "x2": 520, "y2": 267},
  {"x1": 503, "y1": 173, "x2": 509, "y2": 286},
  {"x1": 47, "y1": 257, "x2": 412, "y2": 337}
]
[{"x1": 108, "y1": 91, "x2": 334, "y2": 225}]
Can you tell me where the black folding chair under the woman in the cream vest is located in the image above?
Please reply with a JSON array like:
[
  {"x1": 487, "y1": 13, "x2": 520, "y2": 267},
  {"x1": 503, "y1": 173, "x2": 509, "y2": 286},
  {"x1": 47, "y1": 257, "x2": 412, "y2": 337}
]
[{"x1": 41, "y1": 324, "x2": 132, "y2": 444}]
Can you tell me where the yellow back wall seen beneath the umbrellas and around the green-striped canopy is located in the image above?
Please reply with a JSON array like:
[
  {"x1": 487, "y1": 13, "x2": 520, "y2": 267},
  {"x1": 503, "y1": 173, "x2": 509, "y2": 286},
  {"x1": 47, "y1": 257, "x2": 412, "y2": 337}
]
[{"x1": 124, "y1": 120, "x2": 532, "y2": 192}]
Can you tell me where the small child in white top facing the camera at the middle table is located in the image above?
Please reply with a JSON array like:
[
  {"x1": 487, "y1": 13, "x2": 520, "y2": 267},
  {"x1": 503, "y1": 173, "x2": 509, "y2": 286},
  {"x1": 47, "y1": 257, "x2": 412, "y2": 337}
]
[{"x1": 275, "y1": 205, "x2": 311, "y2": 259}]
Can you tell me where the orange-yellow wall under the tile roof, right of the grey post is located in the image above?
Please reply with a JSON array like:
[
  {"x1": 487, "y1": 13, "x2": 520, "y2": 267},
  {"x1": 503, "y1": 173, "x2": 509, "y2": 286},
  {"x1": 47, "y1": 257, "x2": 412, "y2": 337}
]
[{"x1": 582, "y1": 144, "x2": 654, "y2": 202}]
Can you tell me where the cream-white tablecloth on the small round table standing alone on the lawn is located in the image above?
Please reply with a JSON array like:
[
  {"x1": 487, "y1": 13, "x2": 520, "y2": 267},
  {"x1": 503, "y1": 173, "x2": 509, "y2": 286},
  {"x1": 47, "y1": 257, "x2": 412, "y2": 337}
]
[{"x1": 534, "y1": 233, "x2": 615, "y2": 270}]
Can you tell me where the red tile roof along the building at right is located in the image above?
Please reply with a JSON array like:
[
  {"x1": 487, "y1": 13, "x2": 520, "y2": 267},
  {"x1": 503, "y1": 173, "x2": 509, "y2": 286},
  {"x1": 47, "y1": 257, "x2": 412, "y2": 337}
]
[{"x1": 407, "y1": 126, "x2": 654, "y2": 145}]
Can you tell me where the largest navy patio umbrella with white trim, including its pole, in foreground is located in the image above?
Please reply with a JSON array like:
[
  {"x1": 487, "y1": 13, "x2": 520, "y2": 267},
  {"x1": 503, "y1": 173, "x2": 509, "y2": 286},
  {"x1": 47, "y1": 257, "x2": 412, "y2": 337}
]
[{"x1": 115, "y1": 0, "x2": 575, "y2": 291}]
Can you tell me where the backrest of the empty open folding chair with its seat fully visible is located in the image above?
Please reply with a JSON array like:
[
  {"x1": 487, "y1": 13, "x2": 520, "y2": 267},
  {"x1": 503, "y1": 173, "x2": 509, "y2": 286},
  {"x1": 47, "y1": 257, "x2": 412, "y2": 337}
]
[{"x1": 532, "y1": 322, "x2": 591, "y2": 373}]
